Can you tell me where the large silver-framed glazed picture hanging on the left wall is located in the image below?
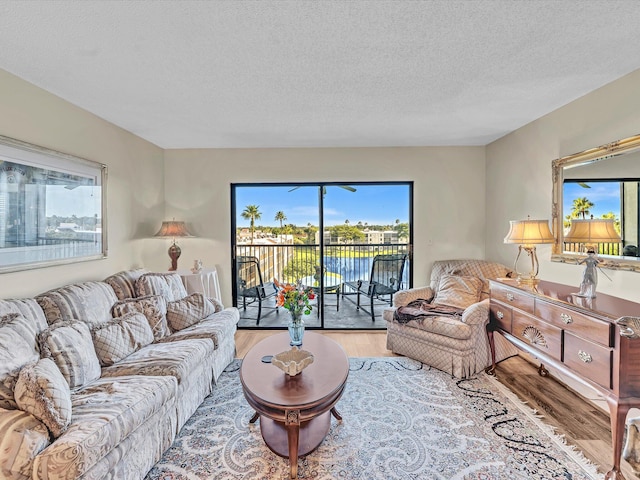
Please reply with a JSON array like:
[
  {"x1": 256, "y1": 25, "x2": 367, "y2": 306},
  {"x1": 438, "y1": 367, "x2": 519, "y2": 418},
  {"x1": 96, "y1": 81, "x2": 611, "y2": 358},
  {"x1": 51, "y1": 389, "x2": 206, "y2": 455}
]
[{"x1": 0, "y1": 137, "x2": 106, "y2": 272}]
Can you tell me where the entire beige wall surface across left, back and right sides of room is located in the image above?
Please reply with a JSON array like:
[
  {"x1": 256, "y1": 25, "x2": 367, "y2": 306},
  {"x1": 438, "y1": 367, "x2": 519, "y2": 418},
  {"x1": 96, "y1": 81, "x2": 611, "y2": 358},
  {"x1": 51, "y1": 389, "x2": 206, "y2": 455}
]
[{"x1": 0, "y1": 61, "x2": 640, "y2": 304}]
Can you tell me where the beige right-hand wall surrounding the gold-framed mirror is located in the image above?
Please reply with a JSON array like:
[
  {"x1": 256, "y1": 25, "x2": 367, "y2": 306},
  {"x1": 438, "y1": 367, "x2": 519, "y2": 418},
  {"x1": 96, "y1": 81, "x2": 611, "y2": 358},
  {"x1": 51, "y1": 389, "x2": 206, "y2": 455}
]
[{"x1": 486, "y1": 70, "x2": 640, "y2": 301}]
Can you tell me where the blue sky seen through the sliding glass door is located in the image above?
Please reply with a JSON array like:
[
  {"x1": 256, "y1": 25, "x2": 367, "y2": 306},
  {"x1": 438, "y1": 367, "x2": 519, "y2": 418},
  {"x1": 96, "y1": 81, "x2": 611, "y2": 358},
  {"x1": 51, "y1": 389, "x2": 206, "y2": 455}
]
[{"x1": 236, "y1": 184, "x2": 409, "y2": 227}]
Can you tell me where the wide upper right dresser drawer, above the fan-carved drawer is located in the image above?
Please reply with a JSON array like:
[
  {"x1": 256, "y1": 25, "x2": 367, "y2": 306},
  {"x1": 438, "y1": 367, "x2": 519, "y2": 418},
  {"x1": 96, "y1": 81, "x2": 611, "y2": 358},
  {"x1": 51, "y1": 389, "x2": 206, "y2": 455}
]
[{"x1": 535, "y1": 298, "x2": 613, "y2": 347}]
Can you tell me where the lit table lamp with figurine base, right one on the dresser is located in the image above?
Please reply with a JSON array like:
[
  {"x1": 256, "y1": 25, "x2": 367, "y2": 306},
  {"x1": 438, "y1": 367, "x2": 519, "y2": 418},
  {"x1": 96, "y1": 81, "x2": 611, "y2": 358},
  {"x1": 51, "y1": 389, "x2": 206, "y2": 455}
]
[{"x1": 564, "y1": 217, "x2": 622, "y2": 298}]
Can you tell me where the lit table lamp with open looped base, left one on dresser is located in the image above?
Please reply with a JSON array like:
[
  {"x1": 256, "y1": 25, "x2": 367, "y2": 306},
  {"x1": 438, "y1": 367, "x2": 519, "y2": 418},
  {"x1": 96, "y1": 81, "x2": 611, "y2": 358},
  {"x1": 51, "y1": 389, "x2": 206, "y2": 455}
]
[{"x1": 504, "y1": 217, "x2": 555, "y2": 285}]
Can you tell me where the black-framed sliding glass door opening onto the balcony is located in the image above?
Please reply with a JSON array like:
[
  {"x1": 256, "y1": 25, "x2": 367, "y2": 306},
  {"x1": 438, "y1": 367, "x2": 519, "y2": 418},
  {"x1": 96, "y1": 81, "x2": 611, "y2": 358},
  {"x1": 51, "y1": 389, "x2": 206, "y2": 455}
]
[{"x1": 231, "y1": 182, "x2": 413, "y2": 329}]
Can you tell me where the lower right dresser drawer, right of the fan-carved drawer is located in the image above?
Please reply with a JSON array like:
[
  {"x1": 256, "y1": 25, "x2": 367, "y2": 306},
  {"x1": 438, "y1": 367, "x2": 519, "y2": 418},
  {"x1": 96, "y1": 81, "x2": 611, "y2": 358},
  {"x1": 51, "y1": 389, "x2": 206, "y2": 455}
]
[{"x1": 564, "y1": 332, "x2": 613, "y2": 388}]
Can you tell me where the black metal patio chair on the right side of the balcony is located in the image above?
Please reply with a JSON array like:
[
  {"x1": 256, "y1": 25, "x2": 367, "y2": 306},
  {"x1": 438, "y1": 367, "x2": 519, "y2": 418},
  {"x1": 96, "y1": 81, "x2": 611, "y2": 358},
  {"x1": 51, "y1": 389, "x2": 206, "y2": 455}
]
[{"x1": 342, "y1": 253, "x2": 408, "y2": 321}]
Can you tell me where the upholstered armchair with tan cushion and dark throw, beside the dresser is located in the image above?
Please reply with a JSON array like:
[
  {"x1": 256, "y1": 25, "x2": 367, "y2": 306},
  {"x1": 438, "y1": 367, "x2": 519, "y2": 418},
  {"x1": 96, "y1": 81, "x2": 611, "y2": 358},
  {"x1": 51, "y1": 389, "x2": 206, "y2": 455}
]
[{"x1": 383, "y1": 260, "x2": 517, "y2": 378}]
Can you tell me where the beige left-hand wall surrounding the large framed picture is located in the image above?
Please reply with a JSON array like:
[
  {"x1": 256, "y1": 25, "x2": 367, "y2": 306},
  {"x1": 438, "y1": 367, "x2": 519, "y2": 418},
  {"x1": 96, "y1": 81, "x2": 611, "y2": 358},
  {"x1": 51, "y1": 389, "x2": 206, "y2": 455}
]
[{"x1": 0, "y1": 70, "x2": 164, "y2": 298}]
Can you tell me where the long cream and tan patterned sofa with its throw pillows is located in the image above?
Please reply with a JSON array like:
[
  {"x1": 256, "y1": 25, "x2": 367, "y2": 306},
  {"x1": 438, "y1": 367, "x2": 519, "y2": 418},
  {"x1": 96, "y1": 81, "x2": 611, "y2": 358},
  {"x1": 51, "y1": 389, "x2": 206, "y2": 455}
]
[{"x1": 0, "y1": 270, "x2": 239, "y2": 480}]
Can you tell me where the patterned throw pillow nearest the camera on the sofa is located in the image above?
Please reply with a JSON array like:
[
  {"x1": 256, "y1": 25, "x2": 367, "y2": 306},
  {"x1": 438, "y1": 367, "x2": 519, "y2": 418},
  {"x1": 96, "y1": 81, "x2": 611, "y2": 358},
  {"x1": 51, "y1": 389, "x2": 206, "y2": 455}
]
[{"x1": 15, "y1": 358, "x2": 71, "y2": 438}]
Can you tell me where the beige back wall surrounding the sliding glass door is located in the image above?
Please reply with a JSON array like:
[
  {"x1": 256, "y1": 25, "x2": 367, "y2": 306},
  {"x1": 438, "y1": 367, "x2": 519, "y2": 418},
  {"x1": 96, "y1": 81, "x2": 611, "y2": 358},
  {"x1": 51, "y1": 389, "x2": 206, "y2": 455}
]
[{"x1": 165, "y1": 147, "x2": 485, "y2": 305}]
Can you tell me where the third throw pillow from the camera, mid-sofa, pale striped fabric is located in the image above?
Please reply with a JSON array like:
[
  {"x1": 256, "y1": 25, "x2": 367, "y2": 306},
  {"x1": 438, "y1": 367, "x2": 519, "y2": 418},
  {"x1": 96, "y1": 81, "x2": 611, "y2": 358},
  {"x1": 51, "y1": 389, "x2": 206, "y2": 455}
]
[{"x1": 91, "y1": 312, "x2": 153, "y2": 367}]
